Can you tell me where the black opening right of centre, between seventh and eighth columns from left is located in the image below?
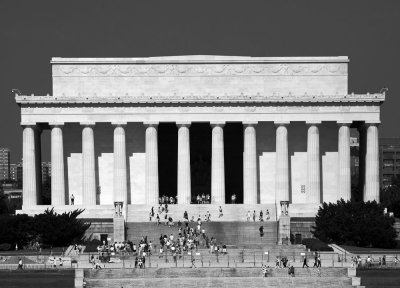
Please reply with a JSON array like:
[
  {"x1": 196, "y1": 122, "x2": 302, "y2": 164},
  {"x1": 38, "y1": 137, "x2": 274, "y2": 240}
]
[{"x1": 224, "y1": 123, "x2": 243, "y2": 203}]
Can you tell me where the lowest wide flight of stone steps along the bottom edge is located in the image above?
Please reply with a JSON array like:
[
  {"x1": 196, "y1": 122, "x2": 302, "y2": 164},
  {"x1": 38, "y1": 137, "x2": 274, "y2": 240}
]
[{"x1": 84, "y1": 267, "x2": 352, "y2": 288}]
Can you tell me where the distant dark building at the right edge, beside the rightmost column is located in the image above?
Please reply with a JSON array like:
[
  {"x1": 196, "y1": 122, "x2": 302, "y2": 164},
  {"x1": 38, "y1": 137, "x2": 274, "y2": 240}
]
[{"x1": 379, "y1": 137, "x2": 400, "y2": 188}]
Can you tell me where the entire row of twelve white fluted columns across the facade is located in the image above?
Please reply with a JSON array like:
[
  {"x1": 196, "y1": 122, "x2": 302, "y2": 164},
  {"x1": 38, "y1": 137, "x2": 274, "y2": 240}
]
[{"x1": 23, "y1": 122, "x2": 379, "y2": 206}]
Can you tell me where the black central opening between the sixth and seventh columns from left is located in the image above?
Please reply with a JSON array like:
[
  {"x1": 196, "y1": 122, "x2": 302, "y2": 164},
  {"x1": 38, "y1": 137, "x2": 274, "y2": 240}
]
[{"x1": 190, "y1": 123, "x2": 211, "y2": 203}]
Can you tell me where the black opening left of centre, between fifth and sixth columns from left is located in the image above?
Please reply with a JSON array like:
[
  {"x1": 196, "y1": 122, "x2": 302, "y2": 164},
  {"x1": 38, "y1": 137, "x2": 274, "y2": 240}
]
[{"x1": 158, "y1": 123, "x2": 178, "y2": 197}]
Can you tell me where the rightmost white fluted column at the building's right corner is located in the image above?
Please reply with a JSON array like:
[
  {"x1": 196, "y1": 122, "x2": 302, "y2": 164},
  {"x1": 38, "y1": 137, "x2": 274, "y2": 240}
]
[{"x1": 364, "y1": 123, "x2": 380, "y2": 203}]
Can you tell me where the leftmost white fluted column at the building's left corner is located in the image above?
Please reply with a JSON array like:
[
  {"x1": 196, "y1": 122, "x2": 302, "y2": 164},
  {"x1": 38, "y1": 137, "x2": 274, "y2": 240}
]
[{"x1": 22, "y1": 125, "x2": 38, "y2": 208}]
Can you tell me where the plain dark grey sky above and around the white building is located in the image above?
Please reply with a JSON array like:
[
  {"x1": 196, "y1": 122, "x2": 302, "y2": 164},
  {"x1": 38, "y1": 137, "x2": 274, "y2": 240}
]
[{"x1": 0, "y1": 0, "x2": 400, "y2": 162}]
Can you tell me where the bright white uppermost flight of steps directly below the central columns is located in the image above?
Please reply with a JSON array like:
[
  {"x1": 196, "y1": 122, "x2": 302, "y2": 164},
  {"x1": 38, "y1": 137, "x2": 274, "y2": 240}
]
[{"x1": 126, "y1": 204, "x2": 276, "y2": 222}]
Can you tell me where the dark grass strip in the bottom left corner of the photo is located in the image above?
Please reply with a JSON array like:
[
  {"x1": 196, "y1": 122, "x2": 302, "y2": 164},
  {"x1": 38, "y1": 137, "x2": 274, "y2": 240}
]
[{"x1": 0, "y1": 269, "x2": 75, "y2": 288}]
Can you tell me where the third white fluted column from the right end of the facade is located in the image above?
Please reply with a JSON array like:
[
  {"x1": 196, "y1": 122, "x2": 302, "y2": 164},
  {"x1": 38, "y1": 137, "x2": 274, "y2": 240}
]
[{"x1": 306, "y1": 123, "x2": 321, "y2": 204}]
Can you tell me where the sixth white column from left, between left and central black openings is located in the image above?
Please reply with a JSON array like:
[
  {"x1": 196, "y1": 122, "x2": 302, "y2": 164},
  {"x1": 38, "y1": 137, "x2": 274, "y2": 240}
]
[{"x1": 177, "y1": 123, "x2": 192, "y2": 204}]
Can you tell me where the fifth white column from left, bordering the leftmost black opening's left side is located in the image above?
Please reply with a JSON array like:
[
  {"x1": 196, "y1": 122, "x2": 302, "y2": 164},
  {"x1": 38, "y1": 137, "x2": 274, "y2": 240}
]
[{"x1": 144, "y1": 122, "x2": 159, "y2": 205}]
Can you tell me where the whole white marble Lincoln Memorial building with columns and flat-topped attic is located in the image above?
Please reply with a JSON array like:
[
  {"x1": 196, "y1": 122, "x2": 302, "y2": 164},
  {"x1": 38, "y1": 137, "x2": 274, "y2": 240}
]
[{"x1": 15, "y1": 55, "x2": 385, "y2": 239}]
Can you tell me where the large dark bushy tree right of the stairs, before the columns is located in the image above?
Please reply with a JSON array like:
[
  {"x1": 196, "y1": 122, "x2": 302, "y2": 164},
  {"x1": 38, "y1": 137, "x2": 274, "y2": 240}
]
[{"x1": 312, "y1": 199, "x2": 396, "y2": 248}]
